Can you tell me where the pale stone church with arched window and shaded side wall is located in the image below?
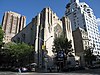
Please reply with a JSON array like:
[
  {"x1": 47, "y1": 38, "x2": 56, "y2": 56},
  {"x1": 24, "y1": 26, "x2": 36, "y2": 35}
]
[{"x1": 12, "y1": 7, "x2": 74, "y2": 70}]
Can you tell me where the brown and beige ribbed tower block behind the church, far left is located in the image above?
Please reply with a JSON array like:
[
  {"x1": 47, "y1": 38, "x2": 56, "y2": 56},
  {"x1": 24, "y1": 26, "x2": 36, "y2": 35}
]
[{"x1": 2, "y1": 11, "x2": 26, "y2": 43}]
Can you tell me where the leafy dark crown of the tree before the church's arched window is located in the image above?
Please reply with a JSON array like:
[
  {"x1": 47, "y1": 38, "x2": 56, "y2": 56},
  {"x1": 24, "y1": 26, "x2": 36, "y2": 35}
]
[{"x1": 53, "y1": 35, "x2": 72, "y2": 55}]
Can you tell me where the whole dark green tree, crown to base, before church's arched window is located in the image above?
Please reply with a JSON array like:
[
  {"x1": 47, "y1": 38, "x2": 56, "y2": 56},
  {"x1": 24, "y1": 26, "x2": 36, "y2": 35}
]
[{"x1": 52, "y1": 35, "x2": 73, "y2": 68}]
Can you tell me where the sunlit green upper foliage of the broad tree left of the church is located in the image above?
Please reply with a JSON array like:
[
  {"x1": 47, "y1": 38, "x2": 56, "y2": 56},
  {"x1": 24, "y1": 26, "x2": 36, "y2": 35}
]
[{"x1": 4, "y1": 42, "x2": 33, "y2": 58}]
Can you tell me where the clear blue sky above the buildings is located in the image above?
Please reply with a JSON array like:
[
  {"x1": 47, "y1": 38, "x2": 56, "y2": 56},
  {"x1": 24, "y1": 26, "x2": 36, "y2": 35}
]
[{"x1": 0, "y1": 0, "x2": 100, "y2": 24}]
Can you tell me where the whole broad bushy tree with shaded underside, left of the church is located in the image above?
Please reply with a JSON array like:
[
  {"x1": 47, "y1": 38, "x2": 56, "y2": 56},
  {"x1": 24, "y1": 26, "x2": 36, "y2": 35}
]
[{"x1": 2, "y1": 42, "x2": 34, "y2": 66}]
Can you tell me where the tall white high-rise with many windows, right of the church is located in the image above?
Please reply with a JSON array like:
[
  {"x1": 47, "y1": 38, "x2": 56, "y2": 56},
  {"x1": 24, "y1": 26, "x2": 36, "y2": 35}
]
[{"x1": 65, "y1": 0, "x2": 100, "y2": 55}]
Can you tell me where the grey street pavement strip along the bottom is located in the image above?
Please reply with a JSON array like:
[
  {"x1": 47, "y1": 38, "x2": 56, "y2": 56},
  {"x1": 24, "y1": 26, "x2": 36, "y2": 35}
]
[{"x1": 0, "y1": 69, "x2": 100, "y2": 75}]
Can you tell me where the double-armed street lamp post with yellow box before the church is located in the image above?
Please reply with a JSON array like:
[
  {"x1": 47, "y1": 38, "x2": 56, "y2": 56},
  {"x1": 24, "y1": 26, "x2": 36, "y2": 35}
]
[{"x1": 38, "y1": 36, "x2": 53, "y2": 72}]
